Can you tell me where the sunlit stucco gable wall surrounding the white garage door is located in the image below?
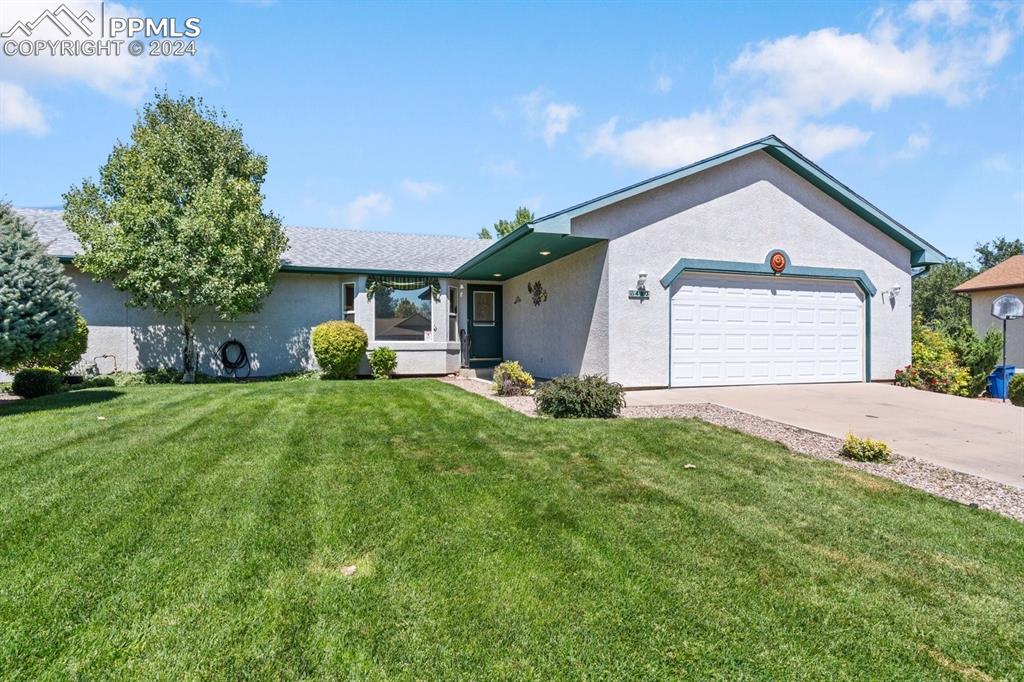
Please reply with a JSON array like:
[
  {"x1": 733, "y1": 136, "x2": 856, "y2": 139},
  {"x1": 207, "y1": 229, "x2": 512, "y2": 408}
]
[{"x1": 569, "y1": 153, "x2": 910, "y2": 387}]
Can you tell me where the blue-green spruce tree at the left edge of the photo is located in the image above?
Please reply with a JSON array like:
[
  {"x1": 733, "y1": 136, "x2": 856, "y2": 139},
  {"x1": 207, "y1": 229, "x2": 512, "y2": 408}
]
[{"x1": 0, "y1": 204, "x2": 78, "y2": 369}]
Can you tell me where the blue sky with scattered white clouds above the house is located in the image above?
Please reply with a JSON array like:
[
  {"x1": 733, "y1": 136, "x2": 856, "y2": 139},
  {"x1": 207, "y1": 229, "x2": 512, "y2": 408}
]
[{"x1": 0, "y1": 1, "x2": 1024, "y2": 258}]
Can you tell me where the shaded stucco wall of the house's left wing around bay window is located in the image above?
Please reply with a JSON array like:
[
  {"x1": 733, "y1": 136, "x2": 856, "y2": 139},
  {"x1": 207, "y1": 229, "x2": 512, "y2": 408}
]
[{"x1": 0, "y1": 265, "x2": 459, "y2": 379}]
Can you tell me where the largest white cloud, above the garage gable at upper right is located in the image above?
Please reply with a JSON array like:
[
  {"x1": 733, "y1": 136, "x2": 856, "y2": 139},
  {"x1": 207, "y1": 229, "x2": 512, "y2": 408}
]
[{"x1": 587, "y1": 7, "x2": 1016, "y2": 170}]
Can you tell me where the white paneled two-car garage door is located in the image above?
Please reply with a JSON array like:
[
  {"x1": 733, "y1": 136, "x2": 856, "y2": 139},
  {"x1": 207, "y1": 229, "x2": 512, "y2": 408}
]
[{"x1": 672, "y1": 274, "x2": 864, "y2": 386}]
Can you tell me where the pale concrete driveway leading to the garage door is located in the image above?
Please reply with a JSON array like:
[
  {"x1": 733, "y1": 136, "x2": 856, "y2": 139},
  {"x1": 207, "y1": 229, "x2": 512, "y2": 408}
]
[{"x1": 626, "y1": 384, "x2": 1024, "y2": 488}]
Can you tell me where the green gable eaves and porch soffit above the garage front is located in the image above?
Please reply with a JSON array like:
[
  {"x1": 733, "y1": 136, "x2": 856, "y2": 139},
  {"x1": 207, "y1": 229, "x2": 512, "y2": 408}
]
[{"x1": 456, "y1": 135, "x2": 946, "y2": 280}]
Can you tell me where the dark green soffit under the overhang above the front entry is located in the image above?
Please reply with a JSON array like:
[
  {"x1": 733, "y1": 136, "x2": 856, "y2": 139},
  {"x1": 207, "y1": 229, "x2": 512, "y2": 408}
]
[{"x1": 453, "y1": 225, "x2": 604, "y2": 282}]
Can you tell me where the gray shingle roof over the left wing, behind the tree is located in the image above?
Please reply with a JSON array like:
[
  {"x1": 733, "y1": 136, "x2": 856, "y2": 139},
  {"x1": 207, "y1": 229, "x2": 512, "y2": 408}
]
[{"x1": 14, "y1": 208, "x2": 494, "y2": 273}]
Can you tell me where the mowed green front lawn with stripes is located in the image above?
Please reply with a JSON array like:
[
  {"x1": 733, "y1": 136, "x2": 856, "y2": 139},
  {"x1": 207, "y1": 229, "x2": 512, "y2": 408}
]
[{"x1": 0, "y1": 380, "x2": 1024, "y2": 680}]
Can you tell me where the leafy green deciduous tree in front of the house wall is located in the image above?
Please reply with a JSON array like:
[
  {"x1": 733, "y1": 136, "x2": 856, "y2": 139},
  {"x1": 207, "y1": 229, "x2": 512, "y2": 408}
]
[{"x1": 65, "y1": 93, "x2": 288, "y2": 383}]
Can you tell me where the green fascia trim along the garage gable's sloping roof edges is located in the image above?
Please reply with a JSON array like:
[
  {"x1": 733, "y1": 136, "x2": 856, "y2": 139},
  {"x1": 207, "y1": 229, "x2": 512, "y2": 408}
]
[{"x1": 532, "y1": 135, "x2": 946, "y2": 267}]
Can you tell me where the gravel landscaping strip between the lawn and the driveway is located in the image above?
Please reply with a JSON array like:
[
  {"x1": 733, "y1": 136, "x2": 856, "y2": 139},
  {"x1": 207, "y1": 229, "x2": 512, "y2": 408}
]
[{"x1": 441, "y1": 377, "x2": 1024, "y2": 521}]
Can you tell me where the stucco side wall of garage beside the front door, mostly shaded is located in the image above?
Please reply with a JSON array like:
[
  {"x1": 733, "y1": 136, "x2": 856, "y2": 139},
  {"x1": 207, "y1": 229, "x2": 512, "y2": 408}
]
[{"x1": 502, "y1": 244, "x2": 608, "y2": 378}]
